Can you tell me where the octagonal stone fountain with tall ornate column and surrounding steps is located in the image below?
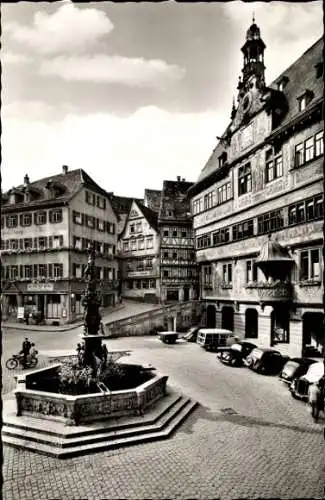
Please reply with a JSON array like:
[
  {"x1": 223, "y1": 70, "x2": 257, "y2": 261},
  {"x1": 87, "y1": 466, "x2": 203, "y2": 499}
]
[{"x1": 2, "y1": 248, "x2": 196, "y2": 458}]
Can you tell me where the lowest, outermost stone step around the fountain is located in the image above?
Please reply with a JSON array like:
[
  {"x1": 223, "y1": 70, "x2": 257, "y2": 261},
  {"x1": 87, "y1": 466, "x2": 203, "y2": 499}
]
[{"x1": 2, "y1": 399, "x2": 198, "y2": 459}]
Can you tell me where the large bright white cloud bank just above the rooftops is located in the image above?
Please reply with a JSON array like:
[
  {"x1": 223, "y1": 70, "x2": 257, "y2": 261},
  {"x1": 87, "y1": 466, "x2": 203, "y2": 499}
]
[{"x1": 2, "y1": 106, "x2": 227, "y2": 196}]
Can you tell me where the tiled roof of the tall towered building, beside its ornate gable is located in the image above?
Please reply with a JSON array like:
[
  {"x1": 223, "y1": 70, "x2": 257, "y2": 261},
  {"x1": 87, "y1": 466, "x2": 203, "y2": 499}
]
[{"x1": 197, "y1": 38, "x2": 324, "y2": 183}]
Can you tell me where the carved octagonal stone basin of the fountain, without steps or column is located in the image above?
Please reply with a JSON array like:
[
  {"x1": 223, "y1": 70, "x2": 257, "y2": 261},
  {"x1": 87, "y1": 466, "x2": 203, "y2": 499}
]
[{"x1": 14, "y1": 363, "x2": 168, "y2": 425}]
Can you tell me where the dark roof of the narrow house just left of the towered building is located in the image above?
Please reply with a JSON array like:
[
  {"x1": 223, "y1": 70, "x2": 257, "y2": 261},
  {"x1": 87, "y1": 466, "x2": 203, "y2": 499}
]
[{"x1": 159, "y1": 181, "x2": 193, "y2": 221}]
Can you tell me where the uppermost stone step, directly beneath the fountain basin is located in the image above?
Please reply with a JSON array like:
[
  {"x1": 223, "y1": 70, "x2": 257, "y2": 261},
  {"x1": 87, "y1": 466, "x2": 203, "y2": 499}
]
[{"x1": 3, "y1": 391, "x2": 183, "y2": 438}]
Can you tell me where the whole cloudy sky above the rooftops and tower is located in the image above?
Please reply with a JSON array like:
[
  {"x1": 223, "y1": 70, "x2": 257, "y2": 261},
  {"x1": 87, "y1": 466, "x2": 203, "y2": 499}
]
[{"x1": 1, "y1": 0, "x2": 323, "y2": 197}]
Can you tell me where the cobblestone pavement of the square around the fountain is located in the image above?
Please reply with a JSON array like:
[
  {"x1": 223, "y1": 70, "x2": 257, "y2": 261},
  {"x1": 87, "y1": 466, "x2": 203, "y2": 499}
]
[{"x1": 3, "y1": 337, "x2": 325, "y2": 500}]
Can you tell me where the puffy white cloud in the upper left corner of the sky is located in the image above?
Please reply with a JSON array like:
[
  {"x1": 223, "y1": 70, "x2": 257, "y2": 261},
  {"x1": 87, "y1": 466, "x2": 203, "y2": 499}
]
[{"x1": 5, "y1": 3, "x2": 114, "y2": 54}]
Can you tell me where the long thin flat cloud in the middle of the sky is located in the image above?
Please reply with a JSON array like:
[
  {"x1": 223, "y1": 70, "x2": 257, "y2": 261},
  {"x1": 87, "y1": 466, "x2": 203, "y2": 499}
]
[{"x1": 40, "y1": 54, "x2": 185, "y2": 87}]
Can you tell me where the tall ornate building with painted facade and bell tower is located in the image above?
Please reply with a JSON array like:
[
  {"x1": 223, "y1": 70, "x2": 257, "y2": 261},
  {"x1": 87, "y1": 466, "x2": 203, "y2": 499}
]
[{"x1": 189, "y1": 22, "x2": 324, "y2": 356}]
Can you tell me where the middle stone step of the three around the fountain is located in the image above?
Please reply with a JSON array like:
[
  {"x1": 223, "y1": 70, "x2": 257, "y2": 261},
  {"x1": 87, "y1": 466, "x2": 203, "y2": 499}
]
[{"x1": 2, "y1": 397, "x2": 189, "y2": 448}]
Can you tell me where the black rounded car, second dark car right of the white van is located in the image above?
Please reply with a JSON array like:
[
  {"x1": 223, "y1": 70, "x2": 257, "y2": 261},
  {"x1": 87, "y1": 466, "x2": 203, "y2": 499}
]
[{"x1": 243, "y1": 347, "x2": 288, "y2": 375}]
